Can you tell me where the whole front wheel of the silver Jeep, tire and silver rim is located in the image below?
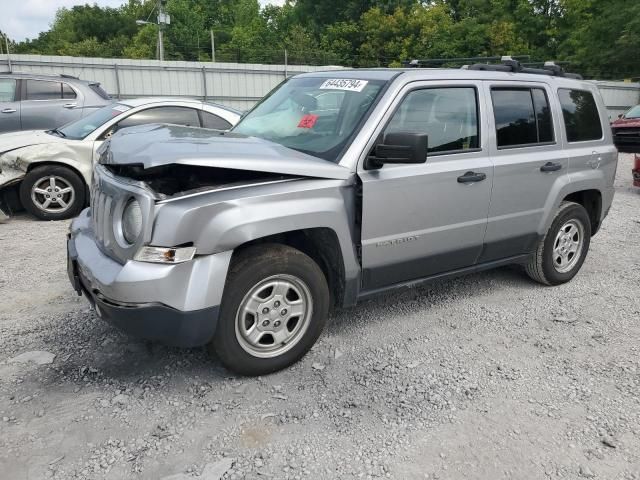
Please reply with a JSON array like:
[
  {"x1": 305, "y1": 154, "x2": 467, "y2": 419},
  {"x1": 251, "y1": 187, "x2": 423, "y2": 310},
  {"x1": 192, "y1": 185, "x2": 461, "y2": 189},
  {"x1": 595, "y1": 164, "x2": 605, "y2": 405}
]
[{"x1": 210, "y1": 244, "x2": 330, "y2": 375}]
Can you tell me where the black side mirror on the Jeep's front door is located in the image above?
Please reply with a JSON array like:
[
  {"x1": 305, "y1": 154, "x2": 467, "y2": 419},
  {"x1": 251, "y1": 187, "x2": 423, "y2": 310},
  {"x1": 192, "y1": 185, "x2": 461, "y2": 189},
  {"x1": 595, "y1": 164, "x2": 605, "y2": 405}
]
[{"x1": 365, "y1": 132, "x2": 429, "y2": 170}]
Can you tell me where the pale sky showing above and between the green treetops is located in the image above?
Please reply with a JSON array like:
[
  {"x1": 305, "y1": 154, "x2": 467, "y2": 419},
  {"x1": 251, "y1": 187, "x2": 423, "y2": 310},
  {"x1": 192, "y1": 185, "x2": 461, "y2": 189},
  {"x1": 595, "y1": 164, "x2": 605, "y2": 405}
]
[{"x1": 0, "y1": 0, "x2": 283, "y2": 42}]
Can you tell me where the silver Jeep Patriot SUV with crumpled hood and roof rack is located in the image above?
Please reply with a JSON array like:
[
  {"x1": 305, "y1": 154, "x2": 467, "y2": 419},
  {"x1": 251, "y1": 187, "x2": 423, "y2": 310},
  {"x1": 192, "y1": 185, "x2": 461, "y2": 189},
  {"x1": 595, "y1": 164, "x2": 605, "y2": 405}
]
[{"x1": 68, "y1": 61, "x2": 617, "y2": 375}]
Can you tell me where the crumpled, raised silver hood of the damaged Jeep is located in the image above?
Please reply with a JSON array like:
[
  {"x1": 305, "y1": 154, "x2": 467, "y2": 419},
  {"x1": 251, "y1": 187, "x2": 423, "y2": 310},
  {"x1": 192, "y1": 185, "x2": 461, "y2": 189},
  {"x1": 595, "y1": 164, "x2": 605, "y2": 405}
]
[{"x1": 106, "y1": 124, "x2": 351, "y2": 180}]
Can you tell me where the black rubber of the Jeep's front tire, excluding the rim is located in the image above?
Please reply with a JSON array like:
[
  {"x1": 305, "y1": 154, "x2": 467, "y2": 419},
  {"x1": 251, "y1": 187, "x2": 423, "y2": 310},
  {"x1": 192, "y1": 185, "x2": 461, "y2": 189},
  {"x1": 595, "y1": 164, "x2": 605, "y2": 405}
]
[{"x1": 213, "y1": 246, "x2": 330, "y2": 375}]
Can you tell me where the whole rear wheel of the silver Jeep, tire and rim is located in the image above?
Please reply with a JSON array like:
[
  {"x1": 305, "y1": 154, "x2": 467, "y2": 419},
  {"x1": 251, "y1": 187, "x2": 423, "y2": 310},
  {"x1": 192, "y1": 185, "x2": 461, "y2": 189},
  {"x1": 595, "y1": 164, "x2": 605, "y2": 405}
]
[{"x1": 526, "y1": 202, "x2": 591, "y2": 285}]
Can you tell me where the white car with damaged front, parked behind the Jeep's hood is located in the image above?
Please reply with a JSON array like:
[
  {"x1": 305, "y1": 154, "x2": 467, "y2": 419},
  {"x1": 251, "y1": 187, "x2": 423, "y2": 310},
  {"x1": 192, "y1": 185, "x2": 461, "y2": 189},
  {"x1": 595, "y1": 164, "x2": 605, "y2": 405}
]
[{"x1": 0, "y1": 98, "x2": 240, "y2": 220}]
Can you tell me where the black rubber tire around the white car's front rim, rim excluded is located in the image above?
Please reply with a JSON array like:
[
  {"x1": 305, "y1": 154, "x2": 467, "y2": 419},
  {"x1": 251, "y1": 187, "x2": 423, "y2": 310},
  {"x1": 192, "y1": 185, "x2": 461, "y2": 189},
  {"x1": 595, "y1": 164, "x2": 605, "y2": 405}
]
[{"x1": 20, "y1": 165, "x2": 86, "y2": 220}]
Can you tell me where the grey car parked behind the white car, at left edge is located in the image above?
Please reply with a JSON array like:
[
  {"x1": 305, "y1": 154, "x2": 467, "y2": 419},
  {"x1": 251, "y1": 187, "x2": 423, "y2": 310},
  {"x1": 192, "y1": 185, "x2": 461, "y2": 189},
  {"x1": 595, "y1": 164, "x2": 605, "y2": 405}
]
[{"x1": 0, "y1": 73, "x2": 113, "y2": 133}]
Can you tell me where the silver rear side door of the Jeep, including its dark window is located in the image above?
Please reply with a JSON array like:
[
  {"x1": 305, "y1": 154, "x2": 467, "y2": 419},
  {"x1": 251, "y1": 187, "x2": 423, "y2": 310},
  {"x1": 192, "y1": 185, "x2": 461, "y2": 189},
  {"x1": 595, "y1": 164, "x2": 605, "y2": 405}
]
[{"x1": 479, "y1": 81, "x2": 569, "y2": 263}]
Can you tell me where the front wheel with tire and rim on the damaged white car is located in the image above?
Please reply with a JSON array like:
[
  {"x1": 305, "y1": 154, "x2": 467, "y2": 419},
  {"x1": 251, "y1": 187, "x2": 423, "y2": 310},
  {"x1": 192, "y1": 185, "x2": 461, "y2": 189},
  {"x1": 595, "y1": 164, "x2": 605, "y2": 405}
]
[{"x1": 20, "y1": 165, "x2": 86, "y2": 220}]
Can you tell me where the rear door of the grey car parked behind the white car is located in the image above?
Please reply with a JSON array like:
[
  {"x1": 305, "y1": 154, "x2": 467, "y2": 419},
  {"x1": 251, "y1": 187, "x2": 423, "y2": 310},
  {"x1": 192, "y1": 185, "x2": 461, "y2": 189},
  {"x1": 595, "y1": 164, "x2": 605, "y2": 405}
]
[{"x1": 21, "y1": 79, "x2": 82, "y2": 130}]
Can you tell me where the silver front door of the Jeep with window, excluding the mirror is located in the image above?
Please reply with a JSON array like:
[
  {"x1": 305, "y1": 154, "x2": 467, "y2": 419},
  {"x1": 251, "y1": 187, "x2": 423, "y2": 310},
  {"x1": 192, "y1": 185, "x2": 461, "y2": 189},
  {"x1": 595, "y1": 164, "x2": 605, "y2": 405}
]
[{"x1": 358, "y1": 81, "x2": 493, "y2": 291}]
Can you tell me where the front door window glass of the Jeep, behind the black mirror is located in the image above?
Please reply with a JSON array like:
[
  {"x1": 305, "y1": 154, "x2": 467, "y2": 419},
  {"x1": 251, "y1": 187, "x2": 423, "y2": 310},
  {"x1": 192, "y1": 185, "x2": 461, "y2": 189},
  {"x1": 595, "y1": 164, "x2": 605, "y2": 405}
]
[{"x1": 385, "y1": 87, "x2": 480, "y2": 153}]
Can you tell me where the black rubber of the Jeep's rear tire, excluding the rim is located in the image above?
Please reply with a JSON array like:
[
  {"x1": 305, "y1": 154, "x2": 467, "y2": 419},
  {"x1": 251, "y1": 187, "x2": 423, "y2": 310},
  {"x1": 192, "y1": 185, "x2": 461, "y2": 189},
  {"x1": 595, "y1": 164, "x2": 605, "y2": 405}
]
[{"x1": 542, "y1": 204, "x2": 591, "y2": 285}]
